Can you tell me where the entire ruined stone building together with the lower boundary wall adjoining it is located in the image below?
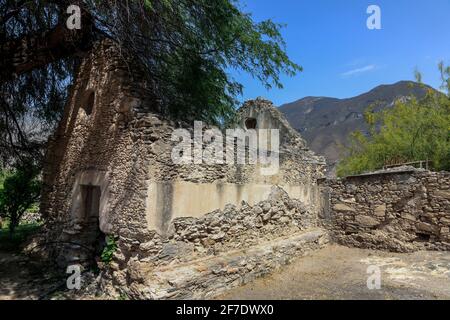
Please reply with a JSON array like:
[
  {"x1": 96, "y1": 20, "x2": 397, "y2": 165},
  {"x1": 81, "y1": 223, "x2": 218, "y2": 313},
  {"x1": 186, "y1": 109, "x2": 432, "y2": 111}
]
[{"x1": 37, "y1": 41, "x2": 450, "y2": 299}]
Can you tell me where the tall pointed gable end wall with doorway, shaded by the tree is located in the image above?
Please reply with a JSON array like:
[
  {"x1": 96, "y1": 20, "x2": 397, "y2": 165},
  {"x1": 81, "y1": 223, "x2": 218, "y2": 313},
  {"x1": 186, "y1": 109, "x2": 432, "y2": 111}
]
[{"x1": 41, "y1": 41, "x2": 156, "y2": 264}]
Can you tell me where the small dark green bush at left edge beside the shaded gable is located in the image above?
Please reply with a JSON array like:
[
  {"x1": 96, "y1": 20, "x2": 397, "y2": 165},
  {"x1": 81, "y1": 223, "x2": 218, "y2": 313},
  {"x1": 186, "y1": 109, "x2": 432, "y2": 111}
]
[{"x1": 0, "y1": 163, "x2": 41, "y2": 234}]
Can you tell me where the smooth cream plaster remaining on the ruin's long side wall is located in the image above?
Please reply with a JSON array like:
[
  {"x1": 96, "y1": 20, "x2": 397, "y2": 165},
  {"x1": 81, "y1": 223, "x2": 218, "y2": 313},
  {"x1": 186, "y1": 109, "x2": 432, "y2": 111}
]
[{"x1": 146, "y1": 181, "x2": 320, "y2": 234}]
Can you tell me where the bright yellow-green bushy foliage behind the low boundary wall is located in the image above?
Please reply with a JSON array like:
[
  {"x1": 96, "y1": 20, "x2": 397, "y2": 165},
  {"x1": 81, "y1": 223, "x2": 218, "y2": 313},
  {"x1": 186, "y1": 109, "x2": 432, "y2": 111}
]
[{"x1": 338, "y1": 65, "x2": 450, "y2": 176}]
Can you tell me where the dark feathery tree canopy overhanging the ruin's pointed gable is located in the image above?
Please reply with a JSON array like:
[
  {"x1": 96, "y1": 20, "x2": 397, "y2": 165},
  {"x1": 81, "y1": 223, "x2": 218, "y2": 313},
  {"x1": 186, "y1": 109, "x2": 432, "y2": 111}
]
[{"x1": 0, "y1": 0, "x2": 301, "y2": 164}]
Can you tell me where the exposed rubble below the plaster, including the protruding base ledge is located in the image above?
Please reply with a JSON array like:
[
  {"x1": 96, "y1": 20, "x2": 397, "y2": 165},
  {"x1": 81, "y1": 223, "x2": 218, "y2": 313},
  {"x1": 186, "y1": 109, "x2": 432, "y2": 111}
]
[{"x1": 106, "y1": 187, "x2": 327, "y2": 299}]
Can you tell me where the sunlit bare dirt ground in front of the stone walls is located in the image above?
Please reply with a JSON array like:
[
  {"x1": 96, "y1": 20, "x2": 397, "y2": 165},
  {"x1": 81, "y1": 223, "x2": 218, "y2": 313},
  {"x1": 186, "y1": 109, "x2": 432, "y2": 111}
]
[{"x1": 219, "y1": 245, "x2": 450, "y2": 300}]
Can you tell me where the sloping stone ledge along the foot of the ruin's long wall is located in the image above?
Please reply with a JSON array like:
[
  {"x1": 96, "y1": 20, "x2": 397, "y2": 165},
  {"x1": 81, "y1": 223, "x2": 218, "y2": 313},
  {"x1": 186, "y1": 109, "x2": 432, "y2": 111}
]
[{"x1": 128, "y1": 229, "x2": 329, "y2": 299}]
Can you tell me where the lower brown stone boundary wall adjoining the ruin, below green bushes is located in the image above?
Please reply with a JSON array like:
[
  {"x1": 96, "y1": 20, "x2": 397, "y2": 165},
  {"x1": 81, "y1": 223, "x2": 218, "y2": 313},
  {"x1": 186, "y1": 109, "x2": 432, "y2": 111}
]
[{"x1": 322, "y1": 169, "x2": 450, "y2": 252}]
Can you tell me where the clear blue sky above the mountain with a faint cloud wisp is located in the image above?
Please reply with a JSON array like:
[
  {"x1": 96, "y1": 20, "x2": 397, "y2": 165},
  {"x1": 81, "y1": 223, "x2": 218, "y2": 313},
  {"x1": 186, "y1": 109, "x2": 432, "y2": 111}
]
[{"x1": 233, "y1": 0, "x2": 450, "y2": 105}]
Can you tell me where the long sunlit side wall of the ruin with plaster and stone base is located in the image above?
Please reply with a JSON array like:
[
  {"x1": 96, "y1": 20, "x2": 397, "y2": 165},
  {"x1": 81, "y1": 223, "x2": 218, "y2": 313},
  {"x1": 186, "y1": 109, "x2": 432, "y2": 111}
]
[{"x1": 109, "y1": 115, "x2": 327, "y2": 299}]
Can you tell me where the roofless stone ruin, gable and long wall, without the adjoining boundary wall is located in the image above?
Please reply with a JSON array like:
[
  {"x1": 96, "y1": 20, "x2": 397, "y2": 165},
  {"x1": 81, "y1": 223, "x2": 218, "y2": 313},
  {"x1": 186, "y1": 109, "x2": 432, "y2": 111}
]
[{"x1": 41, "y1": 41, "x2": 326, "y2": 298}]
